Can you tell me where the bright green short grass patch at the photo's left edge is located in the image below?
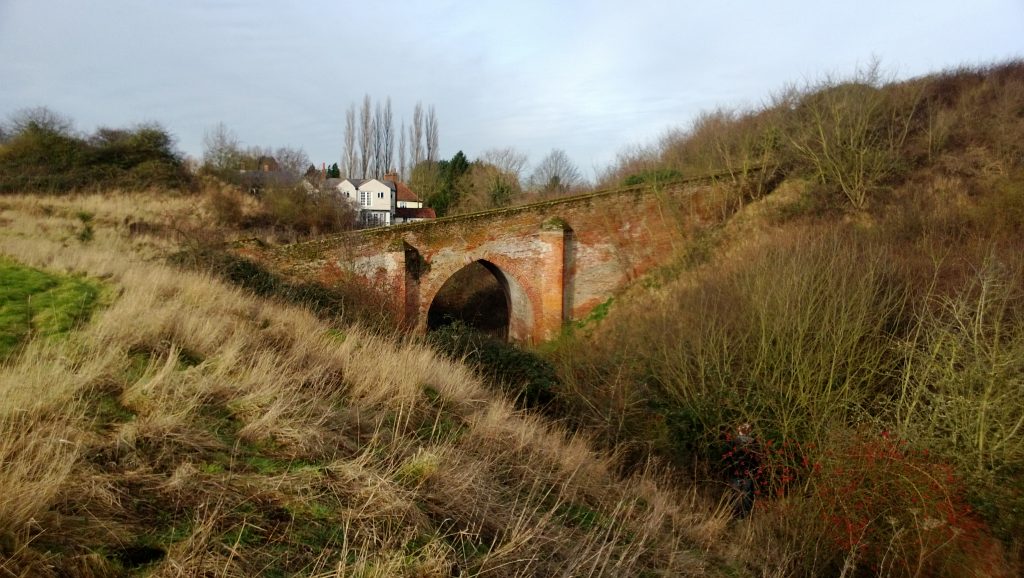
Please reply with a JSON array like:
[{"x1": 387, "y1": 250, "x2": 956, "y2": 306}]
[{"x1": 0, "y1": 257, "x2": 101, "y2": 360}]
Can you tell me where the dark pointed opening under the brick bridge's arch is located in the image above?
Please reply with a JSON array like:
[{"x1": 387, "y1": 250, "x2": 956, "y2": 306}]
[{"x1": 427, "y1": 259, "x2": 532, "y2": 341}]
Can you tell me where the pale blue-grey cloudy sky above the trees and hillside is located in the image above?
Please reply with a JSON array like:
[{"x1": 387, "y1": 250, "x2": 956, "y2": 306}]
[{"x1": 0, "y1": 0, "x2": 1024, "y2": 174}]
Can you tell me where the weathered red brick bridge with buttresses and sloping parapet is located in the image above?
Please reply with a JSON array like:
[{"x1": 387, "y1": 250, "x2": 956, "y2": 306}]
[{"x1": 246, "y1": 177, "x2": 721, "y2": 343}]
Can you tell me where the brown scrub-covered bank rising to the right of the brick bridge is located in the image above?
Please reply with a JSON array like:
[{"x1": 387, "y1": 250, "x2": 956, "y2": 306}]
[{"x1": 552, "y1": 61, "x2": 1024, "y2": 576}]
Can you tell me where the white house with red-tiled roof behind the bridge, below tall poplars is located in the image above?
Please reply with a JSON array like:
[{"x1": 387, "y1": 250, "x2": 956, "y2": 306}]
[{"x1": 324, "y1": 173, "x2": 434, "y2": 228}]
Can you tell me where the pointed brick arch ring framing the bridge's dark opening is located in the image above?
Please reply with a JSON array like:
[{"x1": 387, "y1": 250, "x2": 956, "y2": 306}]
[{"x1": 418, "y1": 254, "x2": 542, "y2": 342}]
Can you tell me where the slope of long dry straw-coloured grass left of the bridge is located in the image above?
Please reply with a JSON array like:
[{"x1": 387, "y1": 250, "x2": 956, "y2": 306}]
[{"x1": 0, "y1": 196, "x2": 724, "y2": 576}]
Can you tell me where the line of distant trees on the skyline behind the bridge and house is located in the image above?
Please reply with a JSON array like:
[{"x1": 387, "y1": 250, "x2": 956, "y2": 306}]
[{"x1": 0, "y1": 101, "x2": 584, "y2": 216}]
